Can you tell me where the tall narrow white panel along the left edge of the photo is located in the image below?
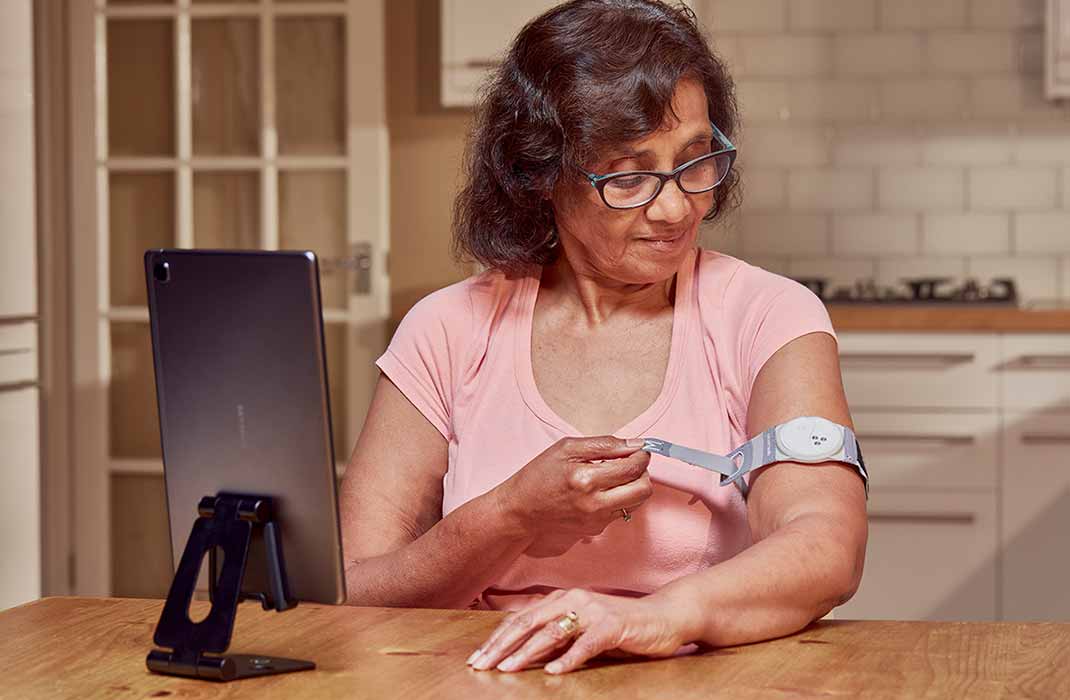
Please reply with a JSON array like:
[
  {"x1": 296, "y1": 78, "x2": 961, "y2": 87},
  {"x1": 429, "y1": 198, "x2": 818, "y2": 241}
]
[{"x1": 0, "y1": 0, "x2": 41, "y2": 609}]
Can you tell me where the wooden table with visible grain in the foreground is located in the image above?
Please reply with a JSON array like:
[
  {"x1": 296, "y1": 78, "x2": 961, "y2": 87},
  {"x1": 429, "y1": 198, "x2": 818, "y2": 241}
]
[{"x1": 0, "y1": 598, "x2": 1070, "y2": 700}]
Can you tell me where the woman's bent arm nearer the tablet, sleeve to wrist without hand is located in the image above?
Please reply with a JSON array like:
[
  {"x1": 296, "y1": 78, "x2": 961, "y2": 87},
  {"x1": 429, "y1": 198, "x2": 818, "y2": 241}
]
[{"x1": 339, "y1": 376, "x2": 531, "y2": 608}]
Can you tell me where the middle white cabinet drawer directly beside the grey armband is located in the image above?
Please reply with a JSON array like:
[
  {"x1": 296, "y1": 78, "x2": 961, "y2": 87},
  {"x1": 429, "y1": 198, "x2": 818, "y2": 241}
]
[{"x1": 852, "y1": 411, "x2": 999, "y2": 490}]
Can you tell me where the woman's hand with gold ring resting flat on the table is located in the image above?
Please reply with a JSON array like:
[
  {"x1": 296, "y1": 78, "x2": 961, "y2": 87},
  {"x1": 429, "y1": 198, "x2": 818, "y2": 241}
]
[{"x1": 468, "y1": 589, "x2": 690, "y2": 673}]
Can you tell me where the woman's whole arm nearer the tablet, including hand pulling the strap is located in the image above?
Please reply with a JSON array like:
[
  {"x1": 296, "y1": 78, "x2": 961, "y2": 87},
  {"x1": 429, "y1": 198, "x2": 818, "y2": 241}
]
[{"x1": 339, "y1": 376, "x2": 652, "y2": 608}]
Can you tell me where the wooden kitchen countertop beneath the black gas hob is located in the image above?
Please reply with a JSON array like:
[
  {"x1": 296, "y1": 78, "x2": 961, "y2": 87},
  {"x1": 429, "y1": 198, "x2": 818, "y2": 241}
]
[{"x1": 826, "y1": 303, "x2": 1070, "y2": 333}]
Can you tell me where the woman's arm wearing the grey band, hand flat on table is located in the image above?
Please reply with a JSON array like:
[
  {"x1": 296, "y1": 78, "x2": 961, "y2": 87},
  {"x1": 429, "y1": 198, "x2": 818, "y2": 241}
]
[{"x1": 473, "y1": 333, "x2": 867, "y2": 673}]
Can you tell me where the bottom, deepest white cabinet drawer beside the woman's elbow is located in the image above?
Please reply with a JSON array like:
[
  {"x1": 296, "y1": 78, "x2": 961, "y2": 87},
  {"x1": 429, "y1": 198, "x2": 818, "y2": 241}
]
[{"x1": 836, "y1": 492, "x2": 996, "y2": 620}]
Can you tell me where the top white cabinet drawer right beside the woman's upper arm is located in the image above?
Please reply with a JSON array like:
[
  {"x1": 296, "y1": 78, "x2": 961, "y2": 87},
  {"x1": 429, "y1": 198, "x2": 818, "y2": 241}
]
[{"x1": 840, "y1": 333, "x2": 999, "y2": 410}]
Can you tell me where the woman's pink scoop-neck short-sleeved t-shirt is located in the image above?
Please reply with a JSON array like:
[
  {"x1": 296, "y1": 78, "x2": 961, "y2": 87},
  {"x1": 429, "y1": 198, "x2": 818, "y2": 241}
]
[{"x1": 376, "y1": 249, "x2": 836, "y2": 609}]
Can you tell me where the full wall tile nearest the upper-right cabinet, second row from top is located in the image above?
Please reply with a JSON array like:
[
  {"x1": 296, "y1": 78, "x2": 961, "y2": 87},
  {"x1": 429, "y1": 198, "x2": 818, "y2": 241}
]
[{"x1": 927, "y1": 31, "x2": 1019, "y2": 75}]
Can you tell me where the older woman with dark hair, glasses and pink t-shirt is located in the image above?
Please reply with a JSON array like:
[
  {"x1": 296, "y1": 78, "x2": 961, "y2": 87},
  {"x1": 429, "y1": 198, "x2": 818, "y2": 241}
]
[{"x1": 341, "y1": 0, "x2": 867, "y2": 673}]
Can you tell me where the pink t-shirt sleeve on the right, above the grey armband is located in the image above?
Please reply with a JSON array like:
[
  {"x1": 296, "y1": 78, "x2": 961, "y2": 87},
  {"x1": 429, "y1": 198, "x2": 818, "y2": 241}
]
[{"x1": 739, "y1": 271, "x2": 836, "y2": 400}]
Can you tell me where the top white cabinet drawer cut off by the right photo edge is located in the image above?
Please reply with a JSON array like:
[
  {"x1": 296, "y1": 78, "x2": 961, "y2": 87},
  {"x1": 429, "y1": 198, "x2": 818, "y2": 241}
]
[{"x1": 999, "y1": 334, "x2": 1070, "y2": 411}]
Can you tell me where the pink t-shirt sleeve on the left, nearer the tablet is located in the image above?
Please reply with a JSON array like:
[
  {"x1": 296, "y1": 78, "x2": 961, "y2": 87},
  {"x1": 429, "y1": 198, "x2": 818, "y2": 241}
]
[{"x1": 376, "y1": 284, "x2": 471, "y2": 440}]
